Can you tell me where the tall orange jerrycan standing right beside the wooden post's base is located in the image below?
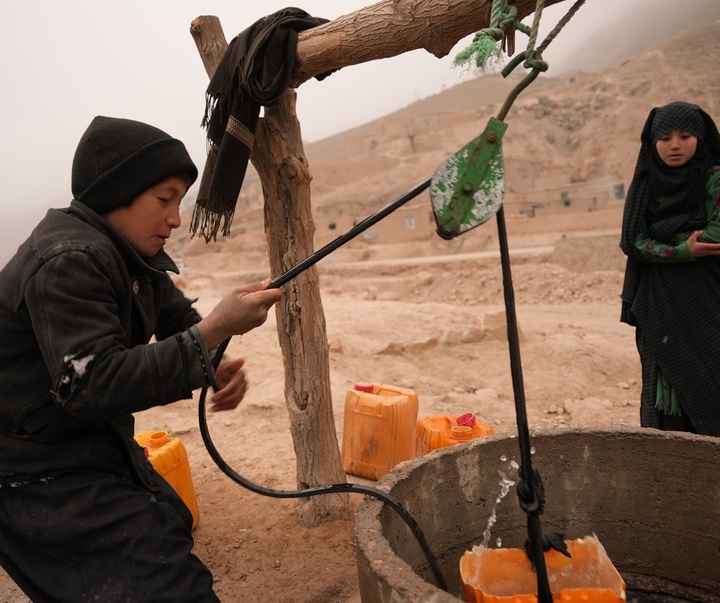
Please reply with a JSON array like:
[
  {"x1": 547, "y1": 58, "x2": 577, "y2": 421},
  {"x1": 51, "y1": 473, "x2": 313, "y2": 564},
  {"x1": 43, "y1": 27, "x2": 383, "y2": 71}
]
[{"x1": 342, "y1": 382, "x2": 418, "y2": 480}]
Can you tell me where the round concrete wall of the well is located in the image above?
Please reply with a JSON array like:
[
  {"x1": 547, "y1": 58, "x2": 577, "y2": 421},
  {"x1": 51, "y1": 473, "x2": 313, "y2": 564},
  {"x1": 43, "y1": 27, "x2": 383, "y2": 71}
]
[{"x1": 355, "y1": 428, "x2": 720, "y2": 603}]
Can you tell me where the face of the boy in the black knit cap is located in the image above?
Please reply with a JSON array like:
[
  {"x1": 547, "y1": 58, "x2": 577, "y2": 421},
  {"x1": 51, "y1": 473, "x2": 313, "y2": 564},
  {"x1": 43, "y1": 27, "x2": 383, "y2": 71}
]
[{"x1": 103, "y1": 176, "x2": 187, "y2": 257}]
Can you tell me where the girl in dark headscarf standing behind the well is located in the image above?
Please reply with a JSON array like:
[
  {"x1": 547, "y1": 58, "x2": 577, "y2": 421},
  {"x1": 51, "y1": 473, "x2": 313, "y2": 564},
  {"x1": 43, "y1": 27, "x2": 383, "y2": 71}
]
[{"x1": 620, "y1": 102, "x2": 720, "y2": 436}]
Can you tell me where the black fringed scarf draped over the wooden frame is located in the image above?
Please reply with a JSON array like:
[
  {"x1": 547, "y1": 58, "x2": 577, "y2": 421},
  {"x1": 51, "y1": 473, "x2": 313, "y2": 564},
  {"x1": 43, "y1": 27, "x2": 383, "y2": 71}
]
[{"x1": 190, "y1": 7, "x2": 328, "y2": 243}]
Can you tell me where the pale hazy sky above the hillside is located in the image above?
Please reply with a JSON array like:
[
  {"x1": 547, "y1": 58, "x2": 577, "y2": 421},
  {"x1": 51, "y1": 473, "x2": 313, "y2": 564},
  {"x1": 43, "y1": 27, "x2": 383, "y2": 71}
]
[{"x1": 0, "y1": 0, "x2": 640, "y2": 266}]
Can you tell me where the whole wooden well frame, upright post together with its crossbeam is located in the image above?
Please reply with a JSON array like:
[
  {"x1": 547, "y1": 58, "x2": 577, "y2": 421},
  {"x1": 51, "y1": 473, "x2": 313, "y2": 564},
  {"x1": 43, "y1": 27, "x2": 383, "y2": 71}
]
[{"x1": 190, "y1": 0, "x2": 564, "y2": 525}]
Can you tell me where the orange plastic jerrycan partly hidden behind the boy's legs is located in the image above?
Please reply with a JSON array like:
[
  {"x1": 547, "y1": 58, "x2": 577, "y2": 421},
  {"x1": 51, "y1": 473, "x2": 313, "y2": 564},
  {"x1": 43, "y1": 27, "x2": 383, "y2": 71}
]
[{"x1": 135, "y1": 431, "x2": 200, "y2": 530}]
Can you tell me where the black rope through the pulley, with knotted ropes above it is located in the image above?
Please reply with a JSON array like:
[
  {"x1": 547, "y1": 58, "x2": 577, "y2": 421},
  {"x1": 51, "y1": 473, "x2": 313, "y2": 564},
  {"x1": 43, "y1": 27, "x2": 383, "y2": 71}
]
[{"x1": 198, "y1": 0, "x2": 585, "y2": 603}]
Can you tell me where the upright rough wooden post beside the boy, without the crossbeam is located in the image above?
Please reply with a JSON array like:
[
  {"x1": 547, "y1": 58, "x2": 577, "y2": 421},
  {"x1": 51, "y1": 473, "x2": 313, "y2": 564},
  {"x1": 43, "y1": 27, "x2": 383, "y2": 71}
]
[{"x1": 190, "y1": 17, "x2": 350, "y2": 526}]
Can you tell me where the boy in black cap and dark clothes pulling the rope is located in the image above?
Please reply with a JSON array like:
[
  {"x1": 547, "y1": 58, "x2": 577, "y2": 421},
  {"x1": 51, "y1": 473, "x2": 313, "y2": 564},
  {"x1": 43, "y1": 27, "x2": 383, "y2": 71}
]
[{"x1": 0, "y1": 116, "x2": 281, "y2": 602}]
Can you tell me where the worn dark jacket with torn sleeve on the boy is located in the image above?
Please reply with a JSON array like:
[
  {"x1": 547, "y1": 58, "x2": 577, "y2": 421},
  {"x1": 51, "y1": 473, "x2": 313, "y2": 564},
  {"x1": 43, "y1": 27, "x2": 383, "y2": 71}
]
[{"x1": 0, "y1": 201, "x2": 212, "y2": 482}]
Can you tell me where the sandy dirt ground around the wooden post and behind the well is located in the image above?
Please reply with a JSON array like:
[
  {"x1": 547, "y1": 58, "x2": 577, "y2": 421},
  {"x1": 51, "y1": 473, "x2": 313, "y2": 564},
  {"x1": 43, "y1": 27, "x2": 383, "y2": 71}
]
[{"x1": 0, "y1": 209, "x2": 640, "y2": 603}]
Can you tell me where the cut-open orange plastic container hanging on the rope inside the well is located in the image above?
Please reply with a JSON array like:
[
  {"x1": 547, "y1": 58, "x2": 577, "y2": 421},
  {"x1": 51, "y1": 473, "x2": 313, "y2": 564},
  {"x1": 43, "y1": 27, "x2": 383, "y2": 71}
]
[{"x1": 460, "y1": 536, "x2": 626, "y2": 603}]
